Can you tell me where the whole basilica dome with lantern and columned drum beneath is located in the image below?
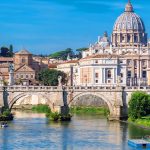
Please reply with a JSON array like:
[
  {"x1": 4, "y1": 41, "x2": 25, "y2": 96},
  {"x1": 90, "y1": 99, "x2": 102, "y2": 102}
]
[{"x1": 111, "y1": 0, "x2": 147, "y2": 47}]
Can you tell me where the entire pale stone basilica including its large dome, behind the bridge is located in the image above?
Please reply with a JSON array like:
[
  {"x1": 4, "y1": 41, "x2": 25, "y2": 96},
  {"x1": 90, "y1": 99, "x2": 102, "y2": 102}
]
[{"x1": 73, "y1": 1, "x2": 150, "y2": 86}]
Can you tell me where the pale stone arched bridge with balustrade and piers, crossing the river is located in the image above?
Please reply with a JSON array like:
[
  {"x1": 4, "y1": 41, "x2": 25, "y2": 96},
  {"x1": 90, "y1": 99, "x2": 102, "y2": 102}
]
[{"x1": 0, "y1": 86, "x2": 150, "y2": 120}]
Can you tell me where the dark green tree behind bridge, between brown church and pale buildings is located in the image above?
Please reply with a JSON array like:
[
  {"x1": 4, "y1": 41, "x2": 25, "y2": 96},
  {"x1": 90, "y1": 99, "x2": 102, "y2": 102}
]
[{"x1": 38, "y1": 69, "x2": 66, "y2": 86}]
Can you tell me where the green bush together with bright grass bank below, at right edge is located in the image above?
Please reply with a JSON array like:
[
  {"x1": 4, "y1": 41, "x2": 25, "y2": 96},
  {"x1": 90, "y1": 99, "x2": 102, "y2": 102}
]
[{"x1": 128, "y1": 91, "x2": 150, "y2": 128}]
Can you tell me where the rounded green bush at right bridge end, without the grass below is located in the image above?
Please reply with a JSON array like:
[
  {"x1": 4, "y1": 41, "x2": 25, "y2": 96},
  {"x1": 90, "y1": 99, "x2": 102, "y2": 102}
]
[{"x1": 128, "y1": 91, "x2": 150, "y2": 120}]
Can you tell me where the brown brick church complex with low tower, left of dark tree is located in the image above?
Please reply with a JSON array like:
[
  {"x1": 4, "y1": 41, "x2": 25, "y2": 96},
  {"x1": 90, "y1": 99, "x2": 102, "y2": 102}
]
[{"x1": 0, "y1": 50, "x2": 49, "y2": 85}]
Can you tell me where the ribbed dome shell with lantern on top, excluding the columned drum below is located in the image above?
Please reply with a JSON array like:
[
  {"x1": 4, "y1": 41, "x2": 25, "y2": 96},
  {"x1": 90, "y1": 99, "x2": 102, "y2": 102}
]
[{"x1": 113, "y1": 2, "x2": 145, "y2": 32}]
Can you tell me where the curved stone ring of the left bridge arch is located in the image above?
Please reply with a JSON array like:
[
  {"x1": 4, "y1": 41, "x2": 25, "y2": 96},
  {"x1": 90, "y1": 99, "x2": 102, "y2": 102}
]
[{"x1": 8, "y1": 93, "x2": 54, "y2": 110}]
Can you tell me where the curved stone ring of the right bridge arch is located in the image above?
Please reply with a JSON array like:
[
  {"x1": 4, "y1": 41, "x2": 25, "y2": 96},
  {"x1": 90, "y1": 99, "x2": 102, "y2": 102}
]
[{"x1": 68, "y1": 92, "x2": 114, "y2": 114}]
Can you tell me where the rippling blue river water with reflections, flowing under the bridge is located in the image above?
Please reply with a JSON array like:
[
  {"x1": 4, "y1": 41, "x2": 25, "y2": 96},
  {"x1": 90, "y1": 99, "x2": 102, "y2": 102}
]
[{"x1": 0, "y1": 111, "x2": 150, "y2": 150}]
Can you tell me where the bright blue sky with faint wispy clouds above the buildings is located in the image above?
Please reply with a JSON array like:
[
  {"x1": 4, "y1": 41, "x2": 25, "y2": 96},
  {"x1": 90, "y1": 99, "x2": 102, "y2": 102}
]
[{"x1": 0, "y1": 0, "x2": 150, "y2": 54}]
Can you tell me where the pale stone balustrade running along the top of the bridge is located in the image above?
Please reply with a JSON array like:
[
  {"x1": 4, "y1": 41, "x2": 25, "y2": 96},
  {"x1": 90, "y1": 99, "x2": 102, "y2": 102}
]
[{"x1": 0, "y1": 86, "x2": 150, "y2": 92}]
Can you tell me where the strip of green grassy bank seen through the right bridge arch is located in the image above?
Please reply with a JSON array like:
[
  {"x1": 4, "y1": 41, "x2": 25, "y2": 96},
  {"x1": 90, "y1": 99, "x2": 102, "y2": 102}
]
[{"x1": 70, "y1": 106, "x2": 109, "y2": 116}]
